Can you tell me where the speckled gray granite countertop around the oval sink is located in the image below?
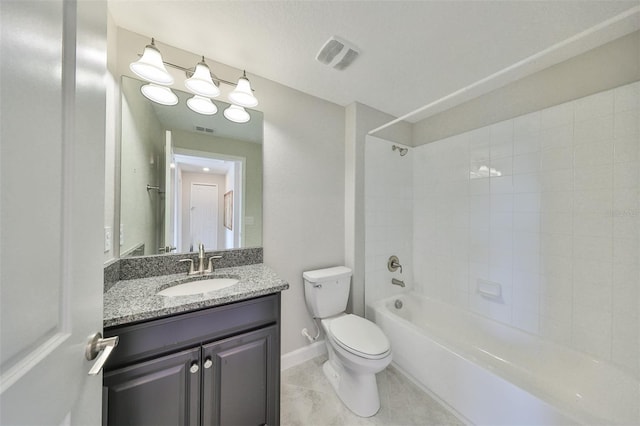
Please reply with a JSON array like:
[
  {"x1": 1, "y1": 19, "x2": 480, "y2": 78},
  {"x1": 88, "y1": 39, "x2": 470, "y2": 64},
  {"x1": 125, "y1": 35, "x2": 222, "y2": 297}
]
[{"x1": 104, "y1": 263, "x2": 289, "y2": 327}]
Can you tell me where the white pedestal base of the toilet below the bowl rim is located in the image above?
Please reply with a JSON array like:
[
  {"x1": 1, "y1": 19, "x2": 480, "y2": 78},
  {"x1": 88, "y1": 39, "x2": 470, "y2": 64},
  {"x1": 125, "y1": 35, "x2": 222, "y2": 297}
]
[{"x1": 322, "y1": 359, "x2": 380, "y2": 417}]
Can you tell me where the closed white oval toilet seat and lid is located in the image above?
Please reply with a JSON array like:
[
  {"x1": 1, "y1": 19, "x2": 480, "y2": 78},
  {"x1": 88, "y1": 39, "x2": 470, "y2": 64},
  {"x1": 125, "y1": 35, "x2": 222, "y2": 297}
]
[{"x1": 329, "y1": 314, "x2": 391, "y2": 359}]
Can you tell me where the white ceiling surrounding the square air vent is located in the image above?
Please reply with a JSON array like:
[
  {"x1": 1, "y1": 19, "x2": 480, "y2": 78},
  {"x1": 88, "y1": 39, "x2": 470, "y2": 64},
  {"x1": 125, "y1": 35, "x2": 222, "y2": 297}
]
[{"x1": 109, "y1": 0, "x2": 640, "y2": 121}]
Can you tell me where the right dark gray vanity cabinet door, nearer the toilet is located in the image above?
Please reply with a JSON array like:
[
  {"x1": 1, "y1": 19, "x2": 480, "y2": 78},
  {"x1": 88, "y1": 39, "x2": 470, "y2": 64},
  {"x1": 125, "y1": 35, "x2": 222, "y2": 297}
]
[{"x1": 202, "y1": 326, "x2": 280, "y2": 426}]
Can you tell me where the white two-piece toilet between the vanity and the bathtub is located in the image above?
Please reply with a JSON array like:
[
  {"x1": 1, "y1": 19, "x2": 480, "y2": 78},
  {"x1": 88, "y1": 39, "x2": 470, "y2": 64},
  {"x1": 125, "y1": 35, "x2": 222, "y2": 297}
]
[{"x1": 302, "y1": 266, "x2": 391, "y2": 417}]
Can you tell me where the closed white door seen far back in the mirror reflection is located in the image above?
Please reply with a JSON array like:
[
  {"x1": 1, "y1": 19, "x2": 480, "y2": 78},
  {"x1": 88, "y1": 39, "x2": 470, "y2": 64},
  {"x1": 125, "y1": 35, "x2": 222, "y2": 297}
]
[{"x1": 190, "y1": 183, "x2": 218, "y2": 250}]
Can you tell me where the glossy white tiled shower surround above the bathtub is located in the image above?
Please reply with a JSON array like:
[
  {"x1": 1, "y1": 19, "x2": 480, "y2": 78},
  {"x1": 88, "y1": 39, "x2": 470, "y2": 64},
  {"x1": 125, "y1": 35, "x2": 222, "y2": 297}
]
[{"x1": 365, "y1": 83, "x2": 640, "y2": 376}]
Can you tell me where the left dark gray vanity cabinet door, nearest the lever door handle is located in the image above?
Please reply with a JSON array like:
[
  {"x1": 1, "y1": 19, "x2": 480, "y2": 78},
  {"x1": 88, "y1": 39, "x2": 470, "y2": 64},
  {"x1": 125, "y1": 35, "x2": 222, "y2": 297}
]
[{"x1": 103, "y1": 347, "x2": 201, "y2": 426}]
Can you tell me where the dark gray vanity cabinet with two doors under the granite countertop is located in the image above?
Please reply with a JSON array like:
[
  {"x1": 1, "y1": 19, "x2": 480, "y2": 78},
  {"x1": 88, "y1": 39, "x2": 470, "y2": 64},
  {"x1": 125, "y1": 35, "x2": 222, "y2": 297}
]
[{"x1": 103, "y1": 293, "x2": 280, "y2": 426}]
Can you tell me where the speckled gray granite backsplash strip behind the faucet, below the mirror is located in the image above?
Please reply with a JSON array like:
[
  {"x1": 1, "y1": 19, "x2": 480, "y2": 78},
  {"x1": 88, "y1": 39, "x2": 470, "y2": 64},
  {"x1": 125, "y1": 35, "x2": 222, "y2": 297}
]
[{"x1": 104, "y1": 247, "x2": 262, "y2": 291}]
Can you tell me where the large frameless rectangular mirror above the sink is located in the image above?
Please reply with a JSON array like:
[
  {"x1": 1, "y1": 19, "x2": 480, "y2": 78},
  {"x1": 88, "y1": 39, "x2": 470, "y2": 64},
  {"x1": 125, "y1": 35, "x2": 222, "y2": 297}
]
[{"x1": 120, "y1": 76, "x2": 263, "y2": 257}]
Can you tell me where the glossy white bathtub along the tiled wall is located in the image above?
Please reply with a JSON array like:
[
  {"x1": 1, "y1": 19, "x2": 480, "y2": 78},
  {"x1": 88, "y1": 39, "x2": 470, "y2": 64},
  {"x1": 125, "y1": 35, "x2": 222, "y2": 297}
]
[{"x1": 368, "y1": 293, "x2": 640, "y2": 425}]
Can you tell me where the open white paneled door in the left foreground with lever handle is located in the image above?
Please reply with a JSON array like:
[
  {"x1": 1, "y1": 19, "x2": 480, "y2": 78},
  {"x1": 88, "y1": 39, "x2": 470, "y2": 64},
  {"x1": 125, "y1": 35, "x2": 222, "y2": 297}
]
[{"x1": 0, "y1": 0, "x2": 106, "y2": 425}]
